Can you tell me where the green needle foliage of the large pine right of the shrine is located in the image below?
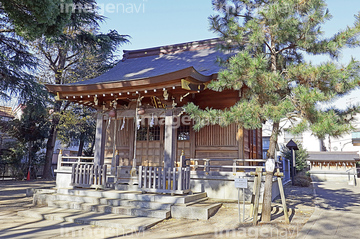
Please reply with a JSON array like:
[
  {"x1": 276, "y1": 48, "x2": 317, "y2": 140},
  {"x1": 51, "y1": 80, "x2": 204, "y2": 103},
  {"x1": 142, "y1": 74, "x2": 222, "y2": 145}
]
[{"x1": 185, "y1": 0, "x2": 360, "y2": 157}]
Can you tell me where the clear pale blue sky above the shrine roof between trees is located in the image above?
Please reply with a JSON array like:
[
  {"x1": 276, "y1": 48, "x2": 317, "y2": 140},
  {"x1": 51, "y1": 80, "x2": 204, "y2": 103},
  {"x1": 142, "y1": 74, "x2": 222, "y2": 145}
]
[{"x1": 98, "y1": 0, "x2": 216, "y2": 50}]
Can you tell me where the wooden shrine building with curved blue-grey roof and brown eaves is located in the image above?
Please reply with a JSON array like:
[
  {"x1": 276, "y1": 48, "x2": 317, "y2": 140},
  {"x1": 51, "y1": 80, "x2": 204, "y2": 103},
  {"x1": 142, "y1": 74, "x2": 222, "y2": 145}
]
[{"x1": 46, "y1": 39, "x2": 264, "y2": 200}]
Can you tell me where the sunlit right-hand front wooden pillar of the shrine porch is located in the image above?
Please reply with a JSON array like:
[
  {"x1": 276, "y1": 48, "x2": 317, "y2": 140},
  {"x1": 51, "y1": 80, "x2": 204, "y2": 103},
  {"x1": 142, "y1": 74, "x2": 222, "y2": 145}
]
[{"x1": 164, "y1": 110, "x2": 177, "y2": 168}]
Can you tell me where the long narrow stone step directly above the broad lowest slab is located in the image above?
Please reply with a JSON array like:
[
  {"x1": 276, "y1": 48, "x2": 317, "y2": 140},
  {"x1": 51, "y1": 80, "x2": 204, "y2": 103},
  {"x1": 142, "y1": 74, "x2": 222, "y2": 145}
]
[{"x1": 48, "y1": 200, "x2": 171, "y2": 219}]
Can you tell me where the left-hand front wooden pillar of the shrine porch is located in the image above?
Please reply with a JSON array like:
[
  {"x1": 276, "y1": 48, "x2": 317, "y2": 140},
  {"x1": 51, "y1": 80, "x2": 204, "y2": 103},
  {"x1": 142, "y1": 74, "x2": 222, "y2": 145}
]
[{"x1": 94, "y1": 110, "x2": 106, "y2": 165}]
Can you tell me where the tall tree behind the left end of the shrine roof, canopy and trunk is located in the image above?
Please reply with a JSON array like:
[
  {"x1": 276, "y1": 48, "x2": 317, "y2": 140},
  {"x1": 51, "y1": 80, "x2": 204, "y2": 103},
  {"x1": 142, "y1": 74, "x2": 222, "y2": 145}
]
[{"x1": 33, "y1": 0, "x2": 128, "y2": 178}]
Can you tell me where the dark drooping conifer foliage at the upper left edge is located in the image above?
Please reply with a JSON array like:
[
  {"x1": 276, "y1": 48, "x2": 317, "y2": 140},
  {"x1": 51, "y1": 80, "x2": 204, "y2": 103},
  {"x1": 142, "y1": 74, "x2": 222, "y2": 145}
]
[{"x1": 0, "y1": 1, "x2": 52, "y2": 102}]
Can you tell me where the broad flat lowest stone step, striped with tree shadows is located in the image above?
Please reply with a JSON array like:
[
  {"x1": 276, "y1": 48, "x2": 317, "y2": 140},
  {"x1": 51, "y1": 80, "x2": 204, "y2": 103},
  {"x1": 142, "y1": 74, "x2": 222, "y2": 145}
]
[{"x1": 18, "y1": 207, "x2": 163, "y2": 230}]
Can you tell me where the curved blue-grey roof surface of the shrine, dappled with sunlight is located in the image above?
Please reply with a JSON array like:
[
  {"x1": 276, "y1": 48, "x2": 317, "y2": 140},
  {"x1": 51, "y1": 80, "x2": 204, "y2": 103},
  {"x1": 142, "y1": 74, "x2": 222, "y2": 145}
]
[{"x1": 74, "y1": 39, "x2": 231, "y2": 85}]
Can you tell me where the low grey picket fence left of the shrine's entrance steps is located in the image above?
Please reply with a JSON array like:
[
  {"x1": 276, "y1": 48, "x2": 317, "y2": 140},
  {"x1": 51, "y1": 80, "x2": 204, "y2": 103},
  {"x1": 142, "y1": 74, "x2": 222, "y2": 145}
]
[{"x1": 71, "y1": 164, "x2": 107, "y2": 188}]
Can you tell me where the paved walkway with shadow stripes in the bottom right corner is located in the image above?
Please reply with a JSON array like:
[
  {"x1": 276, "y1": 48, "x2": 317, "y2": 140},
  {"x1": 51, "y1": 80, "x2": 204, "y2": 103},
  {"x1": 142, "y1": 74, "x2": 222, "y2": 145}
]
[{"x1": 297, "y1": 182, "x2": 360, "y2": 239}]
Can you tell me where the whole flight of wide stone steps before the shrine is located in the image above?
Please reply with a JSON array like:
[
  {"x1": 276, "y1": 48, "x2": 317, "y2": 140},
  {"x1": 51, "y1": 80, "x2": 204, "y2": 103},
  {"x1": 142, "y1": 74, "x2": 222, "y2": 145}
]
[{"x1": 18, "y1": 189, "x2": 221, "y2": 228}]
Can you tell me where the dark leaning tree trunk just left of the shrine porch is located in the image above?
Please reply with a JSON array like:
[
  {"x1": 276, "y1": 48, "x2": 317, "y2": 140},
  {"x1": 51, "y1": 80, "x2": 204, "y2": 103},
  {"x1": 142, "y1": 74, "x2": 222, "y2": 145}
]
[{"x1": 43, "y1": 101, "x2": 62, "y2": 179}]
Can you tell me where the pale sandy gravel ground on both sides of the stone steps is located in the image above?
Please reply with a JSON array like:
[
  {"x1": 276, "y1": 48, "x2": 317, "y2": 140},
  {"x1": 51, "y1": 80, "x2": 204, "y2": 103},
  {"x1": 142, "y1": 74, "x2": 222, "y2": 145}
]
[{"x1": 0, "y1": 181, "x2": 314, "y2": 238}]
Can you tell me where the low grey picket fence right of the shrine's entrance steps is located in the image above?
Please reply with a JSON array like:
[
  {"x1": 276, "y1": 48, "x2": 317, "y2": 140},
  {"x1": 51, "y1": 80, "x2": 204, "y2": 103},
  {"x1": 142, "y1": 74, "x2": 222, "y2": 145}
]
[{"x1": 139, "y1": 166, "x2": 190, "y2": 194}]
